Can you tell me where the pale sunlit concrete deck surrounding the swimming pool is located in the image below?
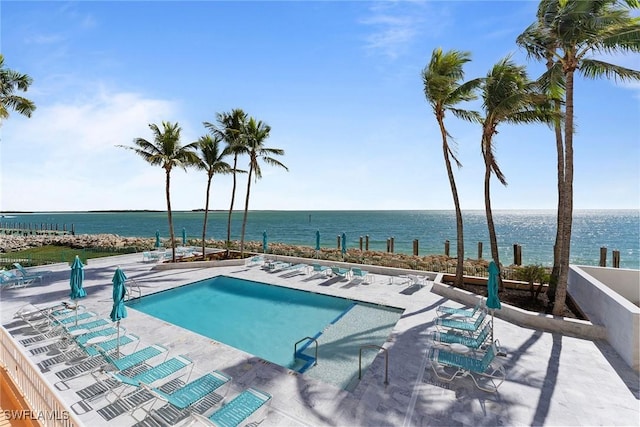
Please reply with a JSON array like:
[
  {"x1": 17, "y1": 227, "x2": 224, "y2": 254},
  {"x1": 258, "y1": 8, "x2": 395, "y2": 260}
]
[{"x1": 1, "y1": 254, "x2": 640, "y2": 427}]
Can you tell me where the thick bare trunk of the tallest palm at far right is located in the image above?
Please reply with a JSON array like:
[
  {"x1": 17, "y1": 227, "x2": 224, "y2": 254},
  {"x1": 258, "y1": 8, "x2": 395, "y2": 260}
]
[{"x1": 553, "y1": 70, "x2": 574, "y2": 316}]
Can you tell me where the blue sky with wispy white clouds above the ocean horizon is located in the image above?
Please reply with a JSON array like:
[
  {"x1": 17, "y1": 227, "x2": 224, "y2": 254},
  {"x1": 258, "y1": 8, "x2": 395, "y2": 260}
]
[{"x1": 0, "y1": 1, "x2": 640, "y2": 211}]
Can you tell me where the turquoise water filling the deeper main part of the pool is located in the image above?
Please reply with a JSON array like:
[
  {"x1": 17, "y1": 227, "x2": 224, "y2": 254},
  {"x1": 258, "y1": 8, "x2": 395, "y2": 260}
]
[{"x1": 131, "y1": 276, "x2": 390, "y2": 374}]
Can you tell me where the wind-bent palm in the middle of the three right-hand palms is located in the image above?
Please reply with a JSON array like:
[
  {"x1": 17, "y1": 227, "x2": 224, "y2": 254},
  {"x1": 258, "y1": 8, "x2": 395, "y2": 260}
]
[{"x1": 481, "y1": 56, "x2": 554, "y2": 287}]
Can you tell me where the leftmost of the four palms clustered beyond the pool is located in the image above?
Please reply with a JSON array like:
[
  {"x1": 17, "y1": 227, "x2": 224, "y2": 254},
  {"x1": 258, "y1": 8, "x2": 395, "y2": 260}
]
[{"x1": 118, "y1": 122, "x2": 199, "y2": 262}]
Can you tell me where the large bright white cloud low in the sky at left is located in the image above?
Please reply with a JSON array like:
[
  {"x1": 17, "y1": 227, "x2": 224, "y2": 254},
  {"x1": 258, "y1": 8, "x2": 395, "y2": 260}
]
[{"x1": 0, "y1": 88, "x2": 180, "y2": 210}]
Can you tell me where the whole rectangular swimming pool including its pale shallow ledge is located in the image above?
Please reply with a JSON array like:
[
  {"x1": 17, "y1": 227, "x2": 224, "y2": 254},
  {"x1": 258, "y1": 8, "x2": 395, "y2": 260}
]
[{"x1": 129, "y1": 276, "x2": 402, "y2": 388}]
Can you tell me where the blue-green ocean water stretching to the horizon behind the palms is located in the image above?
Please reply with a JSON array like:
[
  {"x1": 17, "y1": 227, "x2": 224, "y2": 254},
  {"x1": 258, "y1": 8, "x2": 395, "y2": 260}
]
[{"x1": 0, "y1": 210, "x2": 640, "y2": 269}]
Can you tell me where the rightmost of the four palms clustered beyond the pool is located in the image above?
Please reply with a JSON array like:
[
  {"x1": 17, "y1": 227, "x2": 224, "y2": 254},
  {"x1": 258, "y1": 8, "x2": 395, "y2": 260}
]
[{"x1": 240, "y1": 117, "x2": 289, "y2": 257}]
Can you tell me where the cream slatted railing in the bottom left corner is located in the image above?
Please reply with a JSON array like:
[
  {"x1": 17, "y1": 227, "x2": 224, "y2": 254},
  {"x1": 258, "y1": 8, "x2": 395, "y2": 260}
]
[{"x1": 0, "y1": 327, "x2": 83, "y2": 427}]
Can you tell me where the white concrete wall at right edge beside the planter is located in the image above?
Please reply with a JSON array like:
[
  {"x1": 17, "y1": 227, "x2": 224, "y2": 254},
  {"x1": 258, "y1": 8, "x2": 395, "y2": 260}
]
[{"x1": 567, "y1": 265, "x2": 640, "y2": 371}]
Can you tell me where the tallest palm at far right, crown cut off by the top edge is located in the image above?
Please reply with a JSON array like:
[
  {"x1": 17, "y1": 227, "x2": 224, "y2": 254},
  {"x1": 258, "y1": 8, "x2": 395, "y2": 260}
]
[{"x1": 517, "y1": 0, "x2": 640, "y2": 315}]
